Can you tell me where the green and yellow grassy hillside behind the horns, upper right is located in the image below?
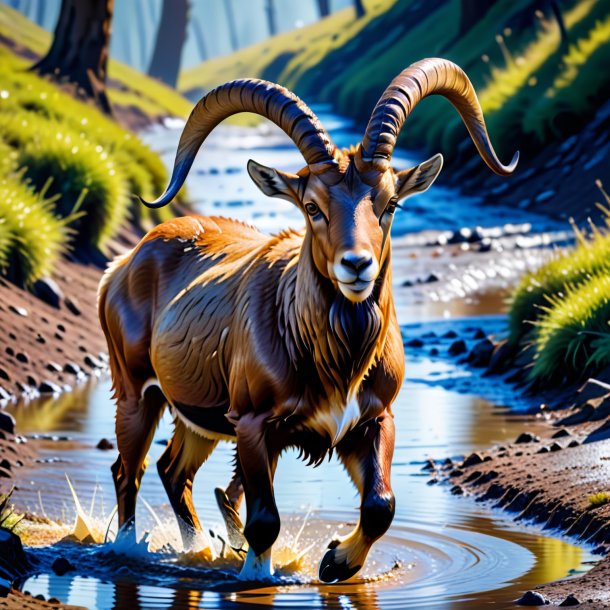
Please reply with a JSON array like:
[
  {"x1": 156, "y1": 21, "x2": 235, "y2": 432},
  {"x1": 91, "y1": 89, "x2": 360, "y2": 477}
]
[{"x1": 179, "y1": 0, "x2": 610, "y2": 163}]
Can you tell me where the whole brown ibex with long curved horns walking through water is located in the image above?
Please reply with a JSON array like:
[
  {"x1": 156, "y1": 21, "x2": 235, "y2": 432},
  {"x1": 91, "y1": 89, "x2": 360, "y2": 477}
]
[{"x1": 99, "y1": 59, "x2": 518, "y2": 582}]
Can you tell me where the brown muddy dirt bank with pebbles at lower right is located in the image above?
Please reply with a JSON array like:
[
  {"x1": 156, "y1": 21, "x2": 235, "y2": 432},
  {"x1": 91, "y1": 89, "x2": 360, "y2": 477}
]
[{"x1": 433, "y1": 385, "x2": 610, "y2": 609}]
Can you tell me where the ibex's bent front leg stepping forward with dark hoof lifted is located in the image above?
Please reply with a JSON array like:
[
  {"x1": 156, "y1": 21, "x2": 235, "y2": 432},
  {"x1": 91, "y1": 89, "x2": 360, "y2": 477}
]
[{"x1": 319, "y1": 412, "x2": 395, "y2": 582}]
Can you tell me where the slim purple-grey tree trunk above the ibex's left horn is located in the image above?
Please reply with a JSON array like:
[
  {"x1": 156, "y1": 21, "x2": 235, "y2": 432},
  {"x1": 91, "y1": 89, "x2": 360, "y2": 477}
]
[{"x1": 148, "y1": 0, "x2": 189, "y2": 88}]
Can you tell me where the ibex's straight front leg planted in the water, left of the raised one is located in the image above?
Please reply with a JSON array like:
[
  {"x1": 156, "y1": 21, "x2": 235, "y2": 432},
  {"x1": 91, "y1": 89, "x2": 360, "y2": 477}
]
[{"x1": 235, "y1": 415, "x2": 280, "y2": 580}]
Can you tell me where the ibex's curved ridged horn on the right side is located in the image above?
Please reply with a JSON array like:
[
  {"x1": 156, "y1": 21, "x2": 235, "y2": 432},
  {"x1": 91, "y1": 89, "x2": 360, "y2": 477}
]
[{"x1": 361, "y1": 58, "x2": 519, "y2": 176}]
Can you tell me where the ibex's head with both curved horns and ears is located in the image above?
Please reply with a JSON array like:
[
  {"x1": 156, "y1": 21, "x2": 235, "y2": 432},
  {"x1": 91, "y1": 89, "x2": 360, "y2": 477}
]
[{"x1": 144, "y1": 59, "x2": 518, "y2": 302}]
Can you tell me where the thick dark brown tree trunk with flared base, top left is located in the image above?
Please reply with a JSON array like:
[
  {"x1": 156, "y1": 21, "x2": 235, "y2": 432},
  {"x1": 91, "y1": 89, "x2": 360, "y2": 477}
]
[{"x1": 31, "y1": 0, "x2": 114, "y2": 114}]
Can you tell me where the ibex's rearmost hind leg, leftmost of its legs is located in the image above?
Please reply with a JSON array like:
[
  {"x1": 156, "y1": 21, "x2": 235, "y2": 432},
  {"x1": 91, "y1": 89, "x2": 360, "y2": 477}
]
[{"x1": 112, "y1": 380, "x2": 166, "y2": 538}]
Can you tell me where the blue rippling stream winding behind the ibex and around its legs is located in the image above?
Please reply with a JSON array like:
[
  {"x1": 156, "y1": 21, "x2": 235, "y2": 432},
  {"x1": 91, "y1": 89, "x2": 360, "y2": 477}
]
[{"x1": 11, "y1": 108, "x2": 595, "y2": 610}]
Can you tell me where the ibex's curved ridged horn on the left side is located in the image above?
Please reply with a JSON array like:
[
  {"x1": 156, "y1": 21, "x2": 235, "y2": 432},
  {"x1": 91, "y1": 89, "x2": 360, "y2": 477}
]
[{"x1": 140, "y1": 79, "x2": 337, "y2": 208}]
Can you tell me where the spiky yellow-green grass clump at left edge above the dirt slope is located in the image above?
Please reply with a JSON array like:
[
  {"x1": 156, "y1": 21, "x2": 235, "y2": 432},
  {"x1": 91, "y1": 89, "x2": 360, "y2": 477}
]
[{"x1": 0, "y1": 171, "x2": 71, "y2": 286}]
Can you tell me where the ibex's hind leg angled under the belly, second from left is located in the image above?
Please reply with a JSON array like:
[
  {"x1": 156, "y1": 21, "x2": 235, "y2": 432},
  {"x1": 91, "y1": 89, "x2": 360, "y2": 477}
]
[{"x1": 157, "y1": 419, "x2": 218, "y2": 549}]
